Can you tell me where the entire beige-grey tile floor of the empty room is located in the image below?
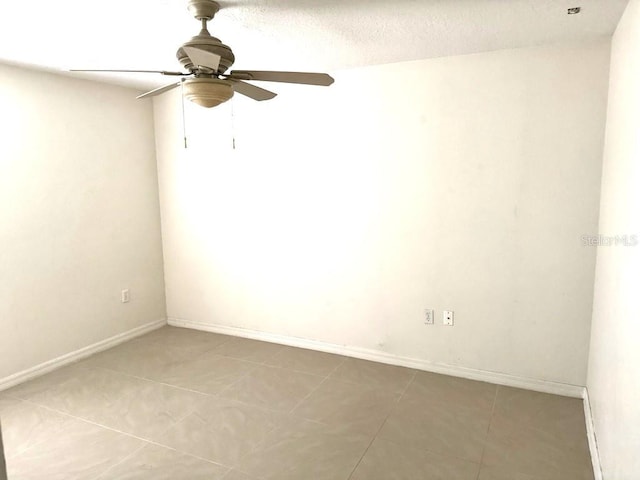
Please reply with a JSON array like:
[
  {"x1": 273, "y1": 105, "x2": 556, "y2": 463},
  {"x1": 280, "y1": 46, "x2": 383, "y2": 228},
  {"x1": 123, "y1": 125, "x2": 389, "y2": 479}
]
[{"x1": 0, "y1": 327, "x2": 594, "y2": 480}]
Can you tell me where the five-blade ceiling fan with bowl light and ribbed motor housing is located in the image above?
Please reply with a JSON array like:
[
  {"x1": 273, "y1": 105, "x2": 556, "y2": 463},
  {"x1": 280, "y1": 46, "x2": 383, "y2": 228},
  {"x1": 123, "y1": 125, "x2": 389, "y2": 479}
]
[{"x1": 71, "y1": 0, "x2": 334, "y2": 108}]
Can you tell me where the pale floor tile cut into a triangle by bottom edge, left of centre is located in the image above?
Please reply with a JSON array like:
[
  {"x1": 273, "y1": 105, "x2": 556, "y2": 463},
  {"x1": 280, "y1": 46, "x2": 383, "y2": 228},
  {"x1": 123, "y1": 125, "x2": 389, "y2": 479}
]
[{"x1": 96, "y1": 444, "x2": 229, "y2": 480}]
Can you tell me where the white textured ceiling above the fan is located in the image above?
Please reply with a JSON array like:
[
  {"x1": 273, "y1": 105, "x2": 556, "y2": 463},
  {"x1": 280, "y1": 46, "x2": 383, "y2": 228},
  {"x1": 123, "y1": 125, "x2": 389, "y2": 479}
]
[{"x1": 0, "y1": 0, "x2": 628, "y2": 88}]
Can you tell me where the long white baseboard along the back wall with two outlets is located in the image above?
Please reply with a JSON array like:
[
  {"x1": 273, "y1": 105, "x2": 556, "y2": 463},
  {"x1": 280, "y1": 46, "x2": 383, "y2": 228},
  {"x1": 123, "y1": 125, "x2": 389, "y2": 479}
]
[{"x1": 168, "y1": 318, "x2": 584, "y2": 398}]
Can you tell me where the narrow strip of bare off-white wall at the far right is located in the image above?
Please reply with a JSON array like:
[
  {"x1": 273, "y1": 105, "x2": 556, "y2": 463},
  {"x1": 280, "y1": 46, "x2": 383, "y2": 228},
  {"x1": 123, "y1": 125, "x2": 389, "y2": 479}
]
[{"x1": 587, "y1": 0, "x2": 640, "y2": 480}]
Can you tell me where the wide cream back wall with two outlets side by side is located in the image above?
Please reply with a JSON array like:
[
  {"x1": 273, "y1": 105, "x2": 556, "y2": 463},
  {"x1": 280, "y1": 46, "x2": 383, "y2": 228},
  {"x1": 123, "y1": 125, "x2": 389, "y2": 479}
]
[{"x1": 154, "y1": 40, "x2": 610, "y2": 385}]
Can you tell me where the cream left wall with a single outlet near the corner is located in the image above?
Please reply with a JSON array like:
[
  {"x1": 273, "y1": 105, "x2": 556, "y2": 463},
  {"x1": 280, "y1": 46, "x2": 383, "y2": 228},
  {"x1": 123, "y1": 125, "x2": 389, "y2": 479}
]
[{"x1": 0, "y1": 65, "x2": 166, "y2": 379}]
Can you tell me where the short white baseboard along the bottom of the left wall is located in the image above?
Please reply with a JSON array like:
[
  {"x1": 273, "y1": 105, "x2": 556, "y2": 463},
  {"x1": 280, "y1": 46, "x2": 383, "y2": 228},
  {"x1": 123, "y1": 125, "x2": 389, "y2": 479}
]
[{"x1": 0, "y1": 318, "x2": 167, "y2": 392}]
